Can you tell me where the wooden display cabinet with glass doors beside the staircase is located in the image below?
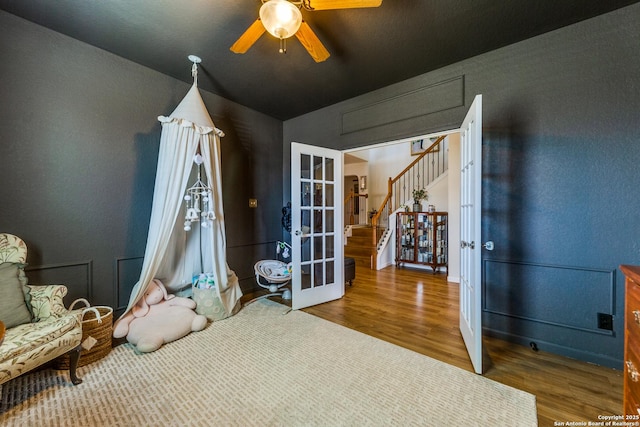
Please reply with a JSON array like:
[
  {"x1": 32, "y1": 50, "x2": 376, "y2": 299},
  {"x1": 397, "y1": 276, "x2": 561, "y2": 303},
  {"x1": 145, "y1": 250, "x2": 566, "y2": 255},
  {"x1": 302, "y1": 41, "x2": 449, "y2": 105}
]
[{"x1": 396, "y1": 212, "x2": 449, "y2": 274}]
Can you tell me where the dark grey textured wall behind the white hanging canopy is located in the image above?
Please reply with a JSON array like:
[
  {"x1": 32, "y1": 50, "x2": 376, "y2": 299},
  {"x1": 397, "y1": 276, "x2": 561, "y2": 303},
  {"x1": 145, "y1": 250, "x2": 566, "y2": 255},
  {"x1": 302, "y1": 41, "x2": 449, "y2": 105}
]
[{"x1": 0, "y1": 12, "x2": 282, "y2": 314}]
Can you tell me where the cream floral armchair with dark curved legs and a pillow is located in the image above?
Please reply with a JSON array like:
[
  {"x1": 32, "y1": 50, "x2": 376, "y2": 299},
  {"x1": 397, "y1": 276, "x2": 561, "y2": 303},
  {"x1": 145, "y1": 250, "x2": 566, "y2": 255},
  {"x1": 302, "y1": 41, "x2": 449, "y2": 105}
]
[{"x1": 0, "y1": 233, "x2": 82, "y2": 384}]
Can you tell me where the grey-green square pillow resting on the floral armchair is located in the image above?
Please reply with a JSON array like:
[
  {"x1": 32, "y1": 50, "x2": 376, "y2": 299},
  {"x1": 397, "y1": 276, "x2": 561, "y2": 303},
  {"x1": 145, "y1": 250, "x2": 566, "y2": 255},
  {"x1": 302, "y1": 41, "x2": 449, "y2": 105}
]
[{"x1": 0, "y1": 262, "x2": 31, "y2": 328}]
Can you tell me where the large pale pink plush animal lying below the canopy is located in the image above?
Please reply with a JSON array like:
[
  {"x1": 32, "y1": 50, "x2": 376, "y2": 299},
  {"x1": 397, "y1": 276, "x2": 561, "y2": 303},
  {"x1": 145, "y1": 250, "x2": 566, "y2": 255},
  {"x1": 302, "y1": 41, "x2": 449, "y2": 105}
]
[{"x1": 113, "y1": 279, "x2": 207, "y2": 353}]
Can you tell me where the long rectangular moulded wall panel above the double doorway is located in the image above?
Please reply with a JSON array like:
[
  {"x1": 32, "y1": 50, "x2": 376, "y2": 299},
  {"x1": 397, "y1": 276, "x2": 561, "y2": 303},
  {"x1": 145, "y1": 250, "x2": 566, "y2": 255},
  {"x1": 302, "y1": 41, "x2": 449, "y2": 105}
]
[{"x1": 342, "y1": 76, "x2": 464, "y2": 135}]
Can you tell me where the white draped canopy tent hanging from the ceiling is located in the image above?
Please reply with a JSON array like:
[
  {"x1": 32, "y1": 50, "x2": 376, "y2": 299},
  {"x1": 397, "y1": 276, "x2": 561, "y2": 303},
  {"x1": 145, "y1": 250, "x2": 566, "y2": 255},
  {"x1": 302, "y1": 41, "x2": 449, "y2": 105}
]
[{"x1": 115, "y1": 68, "x2": 242, "y2": 326}]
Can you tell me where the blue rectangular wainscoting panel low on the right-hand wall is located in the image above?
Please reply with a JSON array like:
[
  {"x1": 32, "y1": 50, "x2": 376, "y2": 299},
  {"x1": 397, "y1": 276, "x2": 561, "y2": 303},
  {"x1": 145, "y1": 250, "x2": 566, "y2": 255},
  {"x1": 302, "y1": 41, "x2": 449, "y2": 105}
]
[{"x1": 483, "y1": 260, "x2": 615, "y2": 335}]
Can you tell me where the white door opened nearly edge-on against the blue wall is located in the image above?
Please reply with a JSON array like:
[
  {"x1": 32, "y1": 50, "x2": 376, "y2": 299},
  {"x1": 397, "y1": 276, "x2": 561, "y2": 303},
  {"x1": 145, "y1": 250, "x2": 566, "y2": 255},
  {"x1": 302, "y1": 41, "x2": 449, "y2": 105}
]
[{"x1": 460, "y1": 95, "x2": 482, "y2": 374}]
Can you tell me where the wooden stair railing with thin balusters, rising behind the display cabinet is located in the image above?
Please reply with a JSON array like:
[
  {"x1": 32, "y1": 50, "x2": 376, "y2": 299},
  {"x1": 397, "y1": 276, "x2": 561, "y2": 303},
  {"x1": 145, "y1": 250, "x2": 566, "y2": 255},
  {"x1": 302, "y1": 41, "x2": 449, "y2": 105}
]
[{"x1": 371, "y1": 135, "x2": 449, "y2": 270}]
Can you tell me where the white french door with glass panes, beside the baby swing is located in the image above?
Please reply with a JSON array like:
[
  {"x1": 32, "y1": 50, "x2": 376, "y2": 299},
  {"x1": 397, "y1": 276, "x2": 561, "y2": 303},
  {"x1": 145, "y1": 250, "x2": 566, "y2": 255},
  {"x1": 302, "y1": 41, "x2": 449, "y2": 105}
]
[{"x1": 291, "y1": 142, "x2": 344, "y2": 310}]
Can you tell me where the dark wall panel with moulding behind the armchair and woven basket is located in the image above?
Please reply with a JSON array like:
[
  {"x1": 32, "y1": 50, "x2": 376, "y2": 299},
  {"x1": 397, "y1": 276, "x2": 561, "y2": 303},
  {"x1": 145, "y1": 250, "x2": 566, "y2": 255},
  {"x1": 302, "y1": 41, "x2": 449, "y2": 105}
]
[{"x1": 25, "y1": 261, "x2": 93, "y2": 307}]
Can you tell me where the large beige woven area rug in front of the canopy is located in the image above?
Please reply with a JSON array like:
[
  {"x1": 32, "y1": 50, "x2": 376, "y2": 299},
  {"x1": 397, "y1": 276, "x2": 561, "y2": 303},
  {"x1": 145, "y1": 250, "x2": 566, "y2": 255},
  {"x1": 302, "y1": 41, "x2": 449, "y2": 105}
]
[{"x1": 0, "y1": 300, "x2": 537, "y2": 427}]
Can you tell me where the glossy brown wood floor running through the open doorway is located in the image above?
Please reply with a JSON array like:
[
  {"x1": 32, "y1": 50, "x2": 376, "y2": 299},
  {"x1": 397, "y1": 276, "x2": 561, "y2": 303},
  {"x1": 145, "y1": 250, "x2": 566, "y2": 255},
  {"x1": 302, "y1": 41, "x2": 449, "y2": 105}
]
[{"x1": 247, "y1": 266, "x2": 622, "y2": 426}]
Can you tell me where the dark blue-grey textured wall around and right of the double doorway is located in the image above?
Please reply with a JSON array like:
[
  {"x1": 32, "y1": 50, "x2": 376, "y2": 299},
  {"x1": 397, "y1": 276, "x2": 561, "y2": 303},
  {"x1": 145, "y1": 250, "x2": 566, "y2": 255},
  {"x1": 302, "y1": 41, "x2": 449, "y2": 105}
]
[{"x1": 284, "y1": 5, "x2": 640, "y2": 367}]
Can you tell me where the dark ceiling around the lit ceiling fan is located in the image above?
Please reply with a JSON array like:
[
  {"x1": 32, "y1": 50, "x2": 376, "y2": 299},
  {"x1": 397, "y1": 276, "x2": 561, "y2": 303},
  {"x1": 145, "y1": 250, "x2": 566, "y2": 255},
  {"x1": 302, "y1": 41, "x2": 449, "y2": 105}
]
[{"x1": 0, "y1": 0, "x2": 639, "y2": 120}]
